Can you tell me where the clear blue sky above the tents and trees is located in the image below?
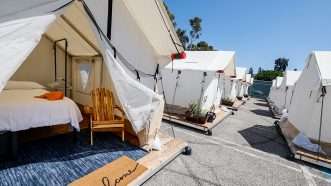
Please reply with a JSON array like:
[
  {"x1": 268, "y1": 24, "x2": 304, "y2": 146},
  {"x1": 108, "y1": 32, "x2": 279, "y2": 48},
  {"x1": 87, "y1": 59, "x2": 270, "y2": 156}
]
[{"x1": 165, "y1": 0, "x2": 331, "y2": 71}]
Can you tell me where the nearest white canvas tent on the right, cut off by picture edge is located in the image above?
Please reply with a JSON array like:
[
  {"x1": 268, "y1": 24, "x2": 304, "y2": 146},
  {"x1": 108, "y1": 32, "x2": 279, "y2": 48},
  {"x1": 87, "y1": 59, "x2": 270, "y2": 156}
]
[{"x1": 288, "y1": 51, "x2": 331, "y2": 143}]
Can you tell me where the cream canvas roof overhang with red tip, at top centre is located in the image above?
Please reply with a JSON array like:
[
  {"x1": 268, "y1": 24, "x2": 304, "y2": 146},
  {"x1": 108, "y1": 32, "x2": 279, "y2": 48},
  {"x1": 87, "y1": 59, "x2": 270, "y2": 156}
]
[{"x1": 123, "y1": 0, "x2": 184, "y2": 57}]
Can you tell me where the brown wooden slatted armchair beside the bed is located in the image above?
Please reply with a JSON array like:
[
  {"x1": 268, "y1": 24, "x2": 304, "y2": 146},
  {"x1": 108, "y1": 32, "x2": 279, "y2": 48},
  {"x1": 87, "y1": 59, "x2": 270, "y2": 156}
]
[{"x1": 85, "y1": 88, "x2": 125, "y2": 145}]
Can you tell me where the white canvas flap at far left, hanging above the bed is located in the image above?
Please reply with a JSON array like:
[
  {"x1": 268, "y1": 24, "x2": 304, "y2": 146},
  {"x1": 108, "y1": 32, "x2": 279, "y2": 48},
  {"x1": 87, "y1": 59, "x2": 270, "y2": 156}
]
[{"x1": 0, "y1": 15, "x2": 56, "y2": 92}]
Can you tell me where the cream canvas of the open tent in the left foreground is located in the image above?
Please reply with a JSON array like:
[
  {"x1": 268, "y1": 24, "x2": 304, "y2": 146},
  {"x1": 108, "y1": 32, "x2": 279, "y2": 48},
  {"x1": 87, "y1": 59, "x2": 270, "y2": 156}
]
[{"x1": 0, "y1": 0, "x2": 181, "y2": 147}]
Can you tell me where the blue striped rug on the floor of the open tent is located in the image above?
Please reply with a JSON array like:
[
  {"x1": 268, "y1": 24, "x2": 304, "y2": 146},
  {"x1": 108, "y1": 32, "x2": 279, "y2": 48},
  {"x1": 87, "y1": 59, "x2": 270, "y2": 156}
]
[{"x1": 0, "y1": 133, "x2": 147, "y2": 186}]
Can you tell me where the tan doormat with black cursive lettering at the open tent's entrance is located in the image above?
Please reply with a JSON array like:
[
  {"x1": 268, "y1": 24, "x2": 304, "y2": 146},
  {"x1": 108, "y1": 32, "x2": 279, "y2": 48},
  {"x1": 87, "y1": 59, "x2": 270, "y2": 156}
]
[{"x1": 70, "y1": 156, "x2": 147, "y2": 186}]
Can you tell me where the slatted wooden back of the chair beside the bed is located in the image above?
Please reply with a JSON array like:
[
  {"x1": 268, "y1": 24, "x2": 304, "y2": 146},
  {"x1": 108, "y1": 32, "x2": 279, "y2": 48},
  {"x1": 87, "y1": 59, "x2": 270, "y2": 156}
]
[{"x1": 91, "y1": 88, "x2": 114, "y2": 121}]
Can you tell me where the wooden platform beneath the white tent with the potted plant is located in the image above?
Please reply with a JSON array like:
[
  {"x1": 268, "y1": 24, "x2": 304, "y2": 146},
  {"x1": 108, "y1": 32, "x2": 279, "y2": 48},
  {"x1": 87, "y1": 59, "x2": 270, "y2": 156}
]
[{"x1": 163, "y1": 109, "x2": 232, "y2": 135}]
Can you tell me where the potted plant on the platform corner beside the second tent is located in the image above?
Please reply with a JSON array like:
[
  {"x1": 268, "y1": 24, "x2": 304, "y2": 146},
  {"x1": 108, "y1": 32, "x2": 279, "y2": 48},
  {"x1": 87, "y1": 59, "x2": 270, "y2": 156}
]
[{"x1": 186, "y1": 103, "x2": 207, "y2": 124}]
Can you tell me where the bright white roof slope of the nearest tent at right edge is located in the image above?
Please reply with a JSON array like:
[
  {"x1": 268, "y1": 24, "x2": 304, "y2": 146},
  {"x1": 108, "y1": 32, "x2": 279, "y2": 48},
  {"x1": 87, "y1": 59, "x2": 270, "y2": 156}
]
[{"x1": 311, "y1": 51, "x2": 331, "y2": 86}]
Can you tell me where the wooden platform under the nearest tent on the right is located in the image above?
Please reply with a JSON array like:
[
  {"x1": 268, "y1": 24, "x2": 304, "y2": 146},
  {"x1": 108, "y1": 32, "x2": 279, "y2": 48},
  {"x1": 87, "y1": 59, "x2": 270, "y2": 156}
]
[{"x1": 278, "y1": 120, "x2": 331, "y2": 169}]
